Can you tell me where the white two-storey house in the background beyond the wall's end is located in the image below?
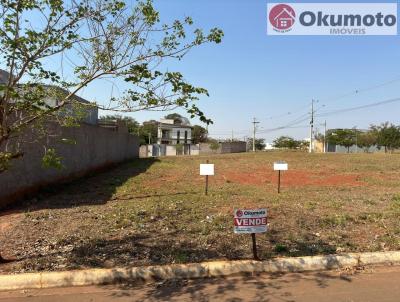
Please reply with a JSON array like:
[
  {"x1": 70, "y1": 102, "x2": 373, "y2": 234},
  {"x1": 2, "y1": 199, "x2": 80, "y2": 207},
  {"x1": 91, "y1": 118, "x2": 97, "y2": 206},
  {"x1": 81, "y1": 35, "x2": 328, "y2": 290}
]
[{"x1": 157, "y1": 117, "x2": 193, "y2": 145}]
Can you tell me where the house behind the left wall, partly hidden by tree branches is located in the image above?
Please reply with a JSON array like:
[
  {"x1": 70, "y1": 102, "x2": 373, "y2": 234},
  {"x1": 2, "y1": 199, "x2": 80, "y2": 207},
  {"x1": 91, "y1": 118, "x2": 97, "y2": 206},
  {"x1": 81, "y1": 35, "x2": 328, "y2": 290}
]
[{"x1": 0, "y1": 69, "x2": 98, "y2": 125}]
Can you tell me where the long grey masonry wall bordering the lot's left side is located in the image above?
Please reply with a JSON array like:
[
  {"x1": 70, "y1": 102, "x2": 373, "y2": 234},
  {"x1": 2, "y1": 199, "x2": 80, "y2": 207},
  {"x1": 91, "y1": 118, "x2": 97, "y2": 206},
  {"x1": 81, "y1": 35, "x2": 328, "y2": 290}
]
[{"x1": 0, "y1": 123, "x2": 139, "y2": 206}]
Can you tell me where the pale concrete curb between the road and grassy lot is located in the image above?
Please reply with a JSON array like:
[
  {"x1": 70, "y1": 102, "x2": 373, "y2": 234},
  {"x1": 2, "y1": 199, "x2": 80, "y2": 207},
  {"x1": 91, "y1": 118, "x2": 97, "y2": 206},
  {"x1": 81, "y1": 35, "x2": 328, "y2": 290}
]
[{"x1": 0, "y1": 251, "x2": 400, "y2": 291}]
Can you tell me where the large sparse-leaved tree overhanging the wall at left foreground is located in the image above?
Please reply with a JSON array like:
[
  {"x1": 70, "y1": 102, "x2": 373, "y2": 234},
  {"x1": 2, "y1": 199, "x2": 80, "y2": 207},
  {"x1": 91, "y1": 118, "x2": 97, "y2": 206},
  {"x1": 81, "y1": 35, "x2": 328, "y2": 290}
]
[{"x1": 0, "y1": 0, "x2": 223, "y2": 172}]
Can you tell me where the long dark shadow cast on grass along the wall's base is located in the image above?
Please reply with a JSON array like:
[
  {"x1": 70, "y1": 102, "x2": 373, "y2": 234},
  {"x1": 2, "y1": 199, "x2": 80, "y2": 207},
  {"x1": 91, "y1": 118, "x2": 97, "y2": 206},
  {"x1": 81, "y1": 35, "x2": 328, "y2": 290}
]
[{"x1": 0, "y1": 158, "x2": 158, "y2": 216}]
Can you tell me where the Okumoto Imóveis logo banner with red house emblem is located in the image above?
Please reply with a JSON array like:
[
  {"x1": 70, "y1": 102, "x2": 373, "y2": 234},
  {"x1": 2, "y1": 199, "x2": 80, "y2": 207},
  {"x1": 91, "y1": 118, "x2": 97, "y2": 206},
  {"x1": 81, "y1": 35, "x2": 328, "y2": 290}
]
[{"x1": 267, "y1": 2, "x2": 397, "y2": 35}]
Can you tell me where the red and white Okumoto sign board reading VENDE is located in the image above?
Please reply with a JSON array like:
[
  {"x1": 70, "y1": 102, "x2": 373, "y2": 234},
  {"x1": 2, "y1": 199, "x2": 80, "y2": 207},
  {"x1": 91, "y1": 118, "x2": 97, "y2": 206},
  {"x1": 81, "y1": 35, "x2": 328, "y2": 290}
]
[{"x1": 234, "y1": 209, "x2": 267, "y2": 234}]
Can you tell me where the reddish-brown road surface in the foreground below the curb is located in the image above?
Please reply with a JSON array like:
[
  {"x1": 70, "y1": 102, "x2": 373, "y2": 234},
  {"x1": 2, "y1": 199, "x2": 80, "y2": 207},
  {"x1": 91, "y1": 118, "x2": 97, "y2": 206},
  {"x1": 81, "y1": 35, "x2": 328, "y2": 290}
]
[{"x1": 0, "y1": 267, "x2": 400, "y2": 302}]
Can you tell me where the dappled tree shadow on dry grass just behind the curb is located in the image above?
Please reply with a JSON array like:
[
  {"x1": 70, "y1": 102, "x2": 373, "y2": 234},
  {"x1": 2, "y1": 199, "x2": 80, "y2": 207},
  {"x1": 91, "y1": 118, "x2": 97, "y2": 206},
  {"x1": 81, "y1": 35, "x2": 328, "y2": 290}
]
[{"x1": 67, "y1": 232, "x2": 223, "y2": 268}]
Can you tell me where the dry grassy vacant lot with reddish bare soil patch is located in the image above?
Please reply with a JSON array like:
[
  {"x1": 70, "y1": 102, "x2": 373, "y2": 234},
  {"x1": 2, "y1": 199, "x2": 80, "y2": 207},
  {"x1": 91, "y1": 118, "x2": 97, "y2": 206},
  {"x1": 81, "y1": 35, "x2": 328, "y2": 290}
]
[{"x1": 0, "y1": 152, "x2": 400, "y2": 273}]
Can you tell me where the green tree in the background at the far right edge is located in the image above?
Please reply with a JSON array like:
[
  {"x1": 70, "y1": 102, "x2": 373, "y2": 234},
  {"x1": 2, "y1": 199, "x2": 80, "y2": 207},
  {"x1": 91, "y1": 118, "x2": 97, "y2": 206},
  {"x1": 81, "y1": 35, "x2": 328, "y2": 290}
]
[{"x1": 371, "y1": 122, "x2": 400, "y2": 153}]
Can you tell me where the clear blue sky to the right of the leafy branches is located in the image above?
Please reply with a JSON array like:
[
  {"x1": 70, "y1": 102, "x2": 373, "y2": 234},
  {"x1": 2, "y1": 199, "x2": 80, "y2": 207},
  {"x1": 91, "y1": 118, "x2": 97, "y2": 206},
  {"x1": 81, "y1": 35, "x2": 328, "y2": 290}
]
[{"x1": 89, "y1": 0, "x2": 400, "y2": 142}]
